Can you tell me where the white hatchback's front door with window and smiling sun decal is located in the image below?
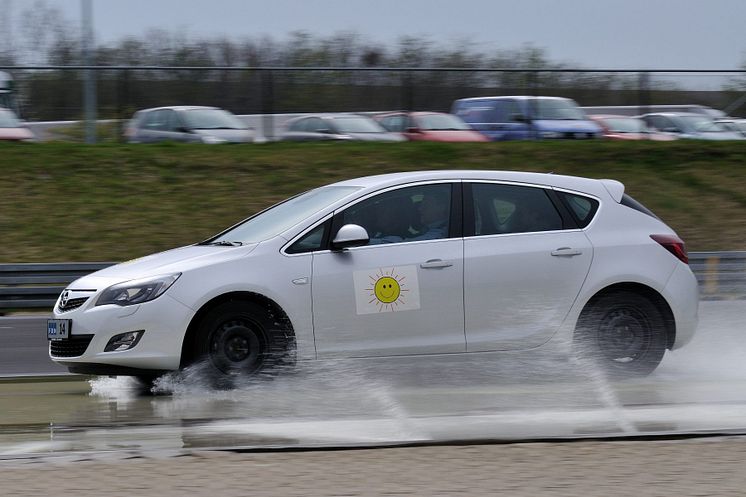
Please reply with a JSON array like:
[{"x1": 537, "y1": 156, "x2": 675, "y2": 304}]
[{"x1": 312, "y1": 183, "x2": 466, "y2": 358}]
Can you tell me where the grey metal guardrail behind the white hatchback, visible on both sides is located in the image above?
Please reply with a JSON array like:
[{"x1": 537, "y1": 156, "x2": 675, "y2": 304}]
[{"x1": 0, "y1": 251, "x2": 746, "y2": 312}]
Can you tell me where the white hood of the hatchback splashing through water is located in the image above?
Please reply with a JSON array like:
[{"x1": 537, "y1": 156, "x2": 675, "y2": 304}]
[{"x1": 70, "y1": 243, "x2": 258, "y2": 290}]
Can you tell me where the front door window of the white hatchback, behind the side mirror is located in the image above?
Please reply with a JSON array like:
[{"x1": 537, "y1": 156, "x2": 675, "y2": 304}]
[{"x1": 340, "y1": 184, "x2": 451, "y2": 245}]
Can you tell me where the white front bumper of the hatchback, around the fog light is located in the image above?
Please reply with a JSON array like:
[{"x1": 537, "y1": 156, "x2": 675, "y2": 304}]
[{"x1": 49, "y1": 294, "x2": 194, "y2": 375}]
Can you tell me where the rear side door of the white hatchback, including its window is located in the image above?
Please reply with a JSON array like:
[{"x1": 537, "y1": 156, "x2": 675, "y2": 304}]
[{"x1": 464, "y1": 182, "x2": 593, "y2": 352}]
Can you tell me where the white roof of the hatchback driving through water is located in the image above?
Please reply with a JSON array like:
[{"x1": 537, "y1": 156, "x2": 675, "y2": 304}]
[{"x1": 330, "y1": 170, "x2": 624, "y2": 197}]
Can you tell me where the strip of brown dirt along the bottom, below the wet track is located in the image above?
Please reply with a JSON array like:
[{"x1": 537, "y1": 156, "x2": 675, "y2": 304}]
[{"x1": 0, "y1": 438, "x2": 746, "y2": 497}]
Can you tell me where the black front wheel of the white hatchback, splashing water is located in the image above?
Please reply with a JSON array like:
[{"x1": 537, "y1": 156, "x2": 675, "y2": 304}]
[{"x1": 192, "y1": 301, "x2": 295, "y2": 388}]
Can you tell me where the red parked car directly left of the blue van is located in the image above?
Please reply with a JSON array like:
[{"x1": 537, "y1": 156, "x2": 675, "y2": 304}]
[{"x1": 373, "y1": 112, "x2": 489, "y2": 142}]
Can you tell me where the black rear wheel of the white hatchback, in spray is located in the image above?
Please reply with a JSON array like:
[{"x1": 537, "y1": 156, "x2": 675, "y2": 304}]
[{"x1": 574, "y1": 291, "x2": 667, "y2": 378}]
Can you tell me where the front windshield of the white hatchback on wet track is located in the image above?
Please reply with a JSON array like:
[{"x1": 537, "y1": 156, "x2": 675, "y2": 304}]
[{"x1": 204, "y1": 186, "x2": 359, "y2": 245}]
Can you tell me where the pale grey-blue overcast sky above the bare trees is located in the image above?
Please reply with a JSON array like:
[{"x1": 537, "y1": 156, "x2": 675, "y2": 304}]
[{"x1": 12, "y1": 0, "x2": 746, "y2": 69}]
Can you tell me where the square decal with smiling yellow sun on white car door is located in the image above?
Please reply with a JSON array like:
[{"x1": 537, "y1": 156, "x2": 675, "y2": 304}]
[{"x1": 354, "y1": 266, "x2": 420, "y2": 314}]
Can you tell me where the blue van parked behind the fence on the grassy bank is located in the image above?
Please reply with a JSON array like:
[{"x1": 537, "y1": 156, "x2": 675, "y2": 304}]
[{"x1": 451, "y1": 96, "x2": 601, "y2": 141}]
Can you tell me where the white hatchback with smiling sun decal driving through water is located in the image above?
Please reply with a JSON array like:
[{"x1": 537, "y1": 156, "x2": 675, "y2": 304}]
[{"x1": 47, "y1": 171, "x2": 698, "y2": 379}]
